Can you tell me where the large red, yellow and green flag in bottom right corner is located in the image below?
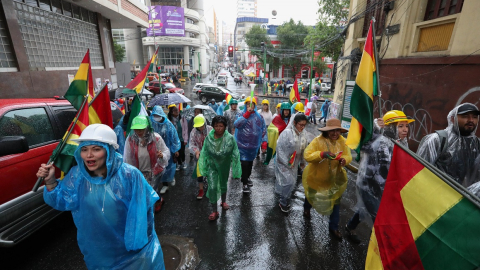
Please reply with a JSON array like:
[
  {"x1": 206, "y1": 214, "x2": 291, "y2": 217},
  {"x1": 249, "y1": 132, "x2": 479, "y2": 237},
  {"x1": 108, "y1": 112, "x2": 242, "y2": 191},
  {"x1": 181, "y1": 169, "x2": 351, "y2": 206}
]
[{"x1": 365, "y1": 145, "x2": 480, "y2": 270}]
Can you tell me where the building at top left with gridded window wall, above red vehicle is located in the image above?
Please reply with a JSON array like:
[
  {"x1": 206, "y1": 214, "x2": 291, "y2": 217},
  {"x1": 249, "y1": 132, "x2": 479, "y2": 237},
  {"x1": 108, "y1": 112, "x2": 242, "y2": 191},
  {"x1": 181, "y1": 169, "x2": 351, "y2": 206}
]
[{"x1": 0, "y1": 0, "x2": 147, "y2": 98}]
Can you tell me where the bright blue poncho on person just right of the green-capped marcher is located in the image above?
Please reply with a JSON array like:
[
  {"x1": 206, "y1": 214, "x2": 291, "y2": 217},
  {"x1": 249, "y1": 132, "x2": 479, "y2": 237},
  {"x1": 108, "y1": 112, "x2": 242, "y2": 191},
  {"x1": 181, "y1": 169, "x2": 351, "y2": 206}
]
[{"x1": 150, "y1": 106, "x2": 181, "y2": 183}]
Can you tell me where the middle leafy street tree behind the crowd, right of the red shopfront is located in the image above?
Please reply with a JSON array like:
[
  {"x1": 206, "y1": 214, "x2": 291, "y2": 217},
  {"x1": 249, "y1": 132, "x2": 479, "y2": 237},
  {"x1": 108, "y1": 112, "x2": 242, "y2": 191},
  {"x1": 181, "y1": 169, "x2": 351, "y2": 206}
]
[{"x1": 277, "y1": 19, "x2": 310, "y2": 77}]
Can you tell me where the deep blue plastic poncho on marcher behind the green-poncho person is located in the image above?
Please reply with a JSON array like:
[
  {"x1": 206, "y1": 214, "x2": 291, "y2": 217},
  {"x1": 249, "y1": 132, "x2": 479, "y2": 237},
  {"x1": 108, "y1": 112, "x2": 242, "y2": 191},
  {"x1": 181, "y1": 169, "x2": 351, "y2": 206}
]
[{"x1": 234, "y1": 106, "x2": 267, "y2": 161}]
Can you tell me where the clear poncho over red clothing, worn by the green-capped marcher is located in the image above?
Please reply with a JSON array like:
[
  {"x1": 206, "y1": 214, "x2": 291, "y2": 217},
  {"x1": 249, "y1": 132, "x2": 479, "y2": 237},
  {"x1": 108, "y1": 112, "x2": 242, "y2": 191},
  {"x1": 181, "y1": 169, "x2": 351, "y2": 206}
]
[{"x1": 123, "y1": 130, "x2": 170, "y2": 187}]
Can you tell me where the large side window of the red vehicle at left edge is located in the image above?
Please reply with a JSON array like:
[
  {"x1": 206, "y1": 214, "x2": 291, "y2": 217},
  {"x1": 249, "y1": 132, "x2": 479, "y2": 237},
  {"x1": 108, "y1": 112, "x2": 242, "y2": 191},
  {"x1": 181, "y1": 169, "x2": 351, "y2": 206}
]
[{"x1": 0, "y1": 108, "x2": 55, "y2": 147}]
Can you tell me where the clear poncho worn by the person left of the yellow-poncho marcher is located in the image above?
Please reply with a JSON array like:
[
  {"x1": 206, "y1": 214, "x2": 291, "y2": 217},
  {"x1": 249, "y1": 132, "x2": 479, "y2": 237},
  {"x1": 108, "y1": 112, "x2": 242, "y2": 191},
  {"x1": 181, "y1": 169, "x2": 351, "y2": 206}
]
[{"x1": 275, "y1": 126, "x2": 307, "y2": 198}]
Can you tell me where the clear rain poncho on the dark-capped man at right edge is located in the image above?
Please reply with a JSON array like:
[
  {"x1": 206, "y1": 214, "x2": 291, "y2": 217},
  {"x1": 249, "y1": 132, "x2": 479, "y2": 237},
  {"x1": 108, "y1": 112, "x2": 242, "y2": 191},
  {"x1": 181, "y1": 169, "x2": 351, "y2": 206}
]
[{"x1": 417, "y1": 103, "x2": 480, "y2": 187}]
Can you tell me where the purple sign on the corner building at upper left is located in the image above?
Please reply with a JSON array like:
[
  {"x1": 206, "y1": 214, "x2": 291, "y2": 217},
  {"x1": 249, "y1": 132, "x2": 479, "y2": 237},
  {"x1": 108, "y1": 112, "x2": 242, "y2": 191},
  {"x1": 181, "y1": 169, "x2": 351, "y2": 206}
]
[{"x1": 147, "y1": 6, "x2": 185, "y2": 37}]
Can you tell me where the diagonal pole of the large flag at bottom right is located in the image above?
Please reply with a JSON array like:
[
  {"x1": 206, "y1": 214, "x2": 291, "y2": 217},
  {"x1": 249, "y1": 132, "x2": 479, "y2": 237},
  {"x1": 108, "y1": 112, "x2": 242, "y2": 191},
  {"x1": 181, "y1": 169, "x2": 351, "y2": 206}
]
[{"x1": 390, "y1": 139, "x2": 480, "y2": 208}]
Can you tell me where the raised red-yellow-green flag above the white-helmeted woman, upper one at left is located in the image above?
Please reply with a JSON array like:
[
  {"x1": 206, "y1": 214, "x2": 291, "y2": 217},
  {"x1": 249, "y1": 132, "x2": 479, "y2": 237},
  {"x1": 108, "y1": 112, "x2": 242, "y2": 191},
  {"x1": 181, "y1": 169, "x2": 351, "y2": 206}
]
[{"x1": 64, "y1": 50, "x2": 93, "y2": 111}]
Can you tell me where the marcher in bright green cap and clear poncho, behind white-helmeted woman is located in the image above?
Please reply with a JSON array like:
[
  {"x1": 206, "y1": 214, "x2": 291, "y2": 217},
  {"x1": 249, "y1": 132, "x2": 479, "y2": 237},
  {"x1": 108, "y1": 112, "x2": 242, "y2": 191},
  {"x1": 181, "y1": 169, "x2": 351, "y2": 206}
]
[{"x1": 123, "y1": 115, "x2": 170, "y2": 212}]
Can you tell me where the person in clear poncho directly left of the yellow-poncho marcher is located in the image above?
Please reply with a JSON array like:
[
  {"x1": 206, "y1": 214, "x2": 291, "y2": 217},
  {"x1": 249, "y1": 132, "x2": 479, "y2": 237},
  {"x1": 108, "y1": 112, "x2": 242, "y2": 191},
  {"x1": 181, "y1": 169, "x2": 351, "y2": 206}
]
[{"x1": 275, "y1": 114, "x2": 307, "y2": 213}]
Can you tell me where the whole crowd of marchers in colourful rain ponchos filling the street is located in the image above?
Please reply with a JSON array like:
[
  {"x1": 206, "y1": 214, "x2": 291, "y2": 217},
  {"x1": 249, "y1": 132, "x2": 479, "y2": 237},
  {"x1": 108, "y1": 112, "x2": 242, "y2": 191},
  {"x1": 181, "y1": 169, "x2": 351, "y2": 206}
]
[{"x1": 37, "y1": 97, "x2": 480, "y2": 269}]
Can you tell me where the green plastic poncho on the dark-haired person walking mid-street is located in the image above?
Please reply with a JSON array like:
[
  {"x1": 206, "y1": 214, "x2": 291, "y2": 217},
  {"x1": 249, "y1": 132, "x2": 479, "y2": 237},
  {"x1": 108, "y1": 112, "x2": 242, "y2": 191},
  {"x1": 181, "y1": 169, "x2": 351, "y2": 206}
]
[{"x1": 198, "y1": 130, "x2": 242, "y2": 203}]
